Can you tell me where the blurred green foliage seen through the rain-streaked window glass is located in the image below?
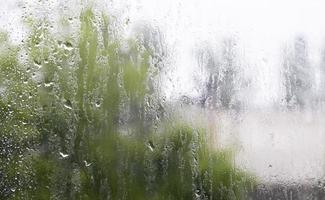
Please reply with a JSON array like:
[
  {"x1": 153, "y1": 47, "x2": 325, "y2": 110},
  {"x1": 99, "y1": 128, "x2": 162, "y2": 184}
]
[{"x1": 0, "y1": 9, "x2": 255, "y2": 200}]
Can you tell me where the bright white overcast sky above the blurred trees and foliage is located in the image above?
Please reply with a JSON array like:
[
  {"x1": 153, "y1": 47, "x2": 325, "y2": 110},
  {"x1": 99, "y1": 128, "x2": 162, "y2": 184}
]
[{"x1": 0, "y1": 0, "x2": 325, "y2": 105}]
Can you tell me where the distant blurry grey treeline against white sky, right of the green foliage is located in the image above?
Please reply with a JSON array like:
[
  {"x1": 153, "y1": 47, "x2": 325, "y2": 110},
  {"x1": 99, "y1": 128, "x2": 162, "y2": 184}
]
[{"x1": 190, "y1": 36, "x2": 325, "y2": 112}]
